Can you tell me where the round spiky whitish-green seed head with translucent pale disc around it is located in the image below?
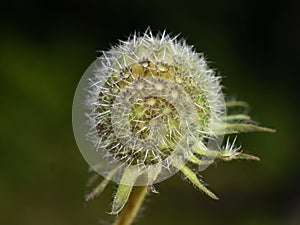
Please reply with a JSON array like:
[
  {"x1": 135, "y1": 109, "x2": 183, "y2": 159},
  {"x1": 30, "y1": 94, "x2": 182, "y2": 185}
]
[{"x1": 73, "y1": 30, "x2": 226, "y2": 185}]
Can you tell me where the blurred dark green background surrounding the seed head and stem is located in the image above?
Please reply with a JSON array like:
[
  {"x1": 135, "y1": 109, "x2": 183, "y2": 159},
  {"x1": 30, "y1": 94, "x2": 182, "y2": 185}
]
[{"x1": 0, "y1": 0, "x2": 300, "y2": 225}]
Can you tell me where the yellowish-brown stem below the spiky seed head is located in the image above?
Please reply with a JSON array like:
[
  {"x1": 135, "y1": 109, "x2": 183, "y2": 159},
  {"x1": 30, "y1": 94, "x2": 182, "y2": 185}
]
[{"x1": 114, "y1": 186, "x2": 147, "y2": 225}]
